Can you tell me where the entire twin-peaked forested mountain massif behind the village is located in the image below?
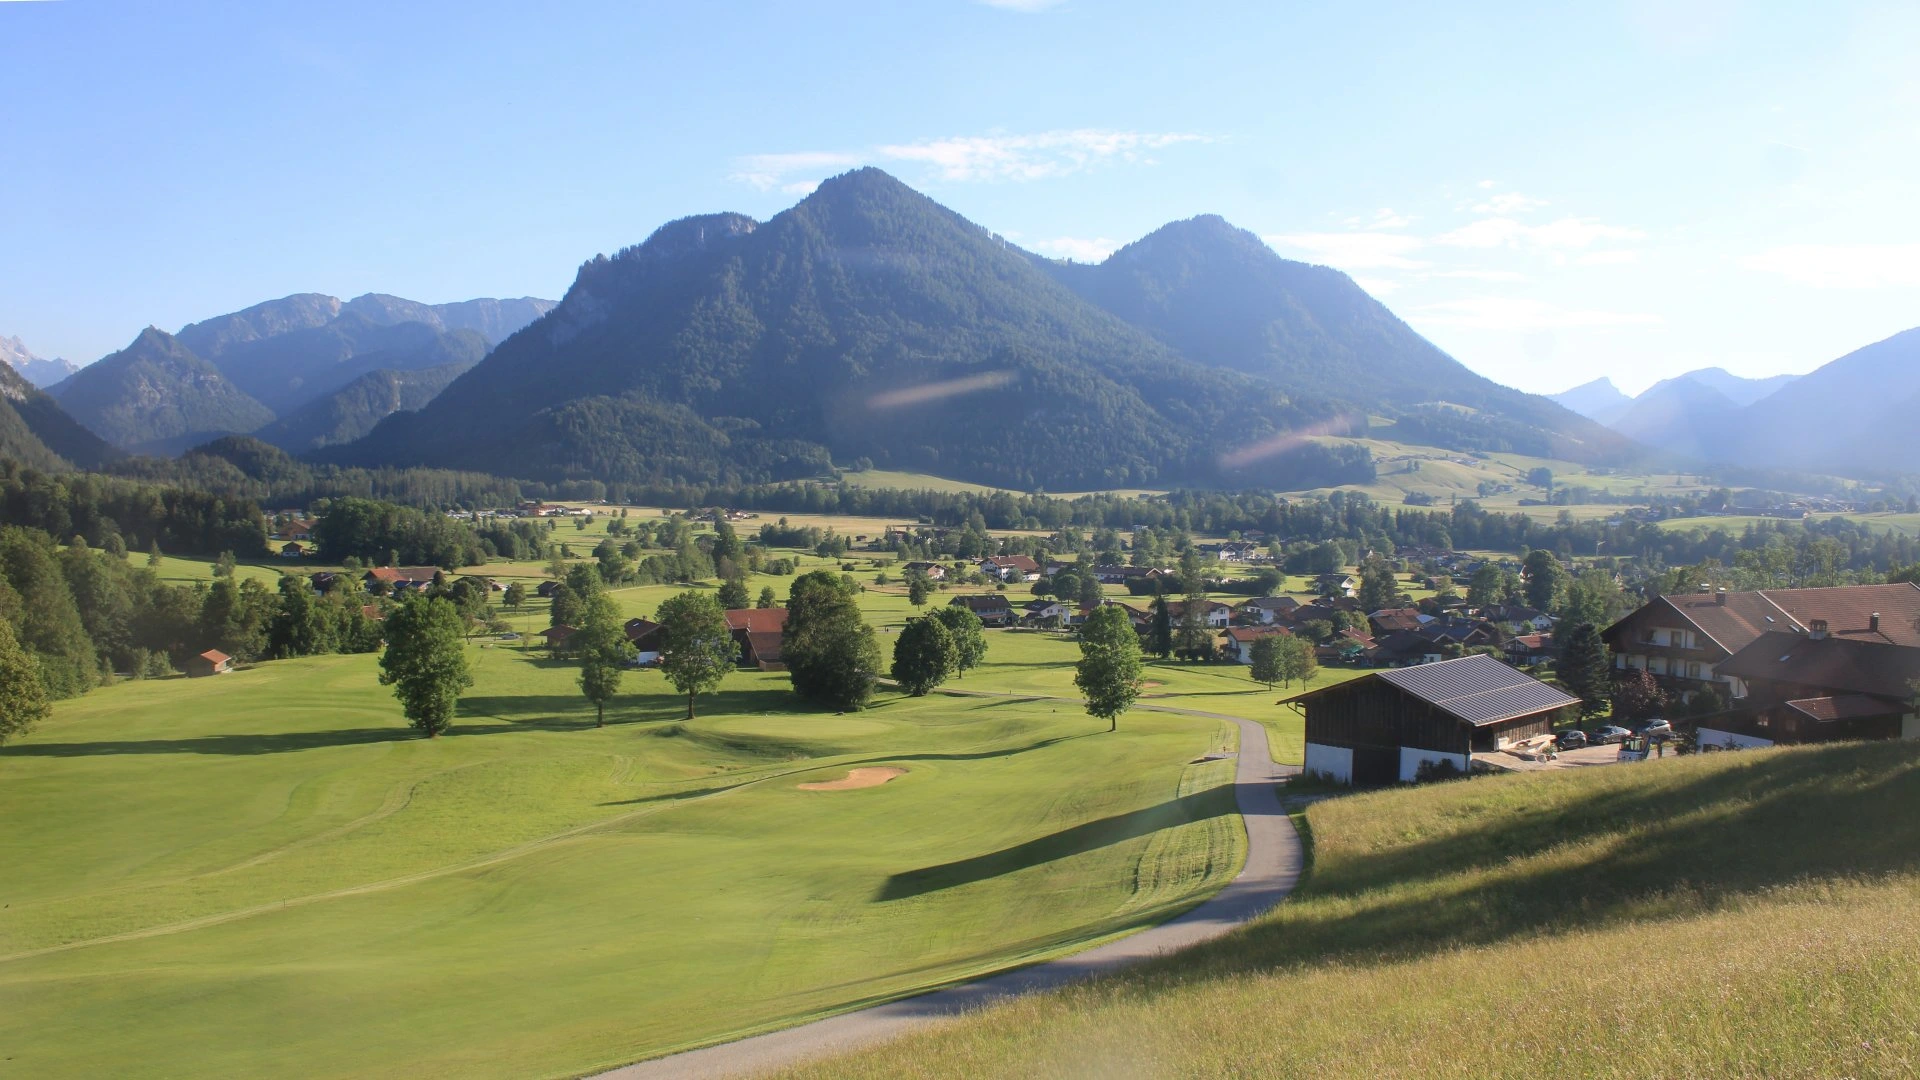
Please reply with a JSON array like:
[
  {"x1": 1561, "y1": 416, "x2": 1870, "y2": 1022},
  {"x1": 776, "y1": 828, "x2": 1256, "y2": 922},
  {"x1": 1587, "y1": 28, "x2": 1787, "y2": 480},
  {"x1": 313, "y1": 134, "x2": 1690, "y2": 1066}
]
[{"x1": 321, "y1": 169, "x2": 1634, "y2": 490}]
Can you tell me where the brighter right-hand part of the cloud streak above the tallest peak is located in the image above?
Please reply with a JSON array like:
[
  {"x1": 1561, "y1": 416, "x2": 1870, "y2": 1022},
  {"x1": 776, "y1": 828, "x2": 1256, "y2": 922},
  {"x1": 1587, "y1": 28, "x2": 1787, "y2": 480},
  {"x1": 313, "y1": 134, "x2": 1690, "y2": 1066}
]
[{"x1": 879, "y1": 129, "x2": 1208, "y2": 183}]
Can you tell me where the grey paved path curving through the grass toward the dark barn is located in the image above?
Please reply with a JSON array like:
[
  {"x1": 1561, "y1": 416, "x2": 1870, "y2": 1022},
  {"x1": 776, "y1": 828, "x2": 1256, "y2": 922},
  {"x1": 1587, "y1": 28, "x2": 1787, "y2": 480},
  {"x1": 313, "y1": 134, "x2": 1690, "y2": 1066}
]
[{"x1": 603, "y1": 692, "x2": 1304, "y2": 1080}]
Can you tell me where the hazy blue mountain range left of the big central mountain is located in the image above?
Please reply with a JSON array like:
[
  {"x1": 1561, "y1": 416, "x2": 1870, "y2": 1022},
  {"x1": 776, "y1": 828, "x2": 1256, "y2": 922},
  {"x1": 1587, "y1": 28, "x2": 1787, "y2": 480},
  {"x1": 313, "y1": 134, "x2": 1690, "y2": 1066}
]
[{"x1": 50, "y1": 292, "x2": 553, "y2": 454}]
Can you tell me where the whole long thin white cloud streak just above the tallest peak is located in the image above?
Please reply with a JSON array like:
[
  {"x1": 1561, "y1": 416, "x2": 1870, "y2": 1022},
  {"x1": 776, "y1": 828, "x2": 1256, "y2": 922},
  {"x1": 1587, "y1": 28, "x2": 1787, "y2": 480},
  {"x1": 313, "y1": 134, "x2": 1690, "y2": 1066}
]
[{"x1": 728, "y1": 129, "x2": 1212, "y2": 194}]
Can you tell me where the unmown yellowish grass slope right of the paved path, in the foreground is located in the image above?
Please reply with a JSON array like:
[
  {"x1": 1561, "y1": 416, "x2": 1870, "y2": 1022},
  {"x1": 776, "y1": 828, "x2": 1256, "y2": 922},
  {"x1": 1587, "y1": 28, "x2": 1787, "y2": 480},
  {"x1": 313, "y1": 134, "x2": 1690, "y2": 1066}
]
[{"x1": 793, "y1": 744, "x2": 1920, "y2": 1078}]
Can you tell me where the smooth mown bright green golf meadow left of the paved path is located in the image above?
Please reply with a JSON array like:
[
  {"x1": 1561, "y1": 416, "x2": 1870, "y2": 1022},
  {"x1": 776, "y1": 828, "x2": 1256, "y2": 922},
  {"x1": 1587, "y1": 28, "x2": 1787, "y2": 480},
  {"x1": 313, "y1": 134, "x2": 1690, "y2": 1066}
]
[{"x1": 0, "y1": 642, "x2": 1244, "y2": 1076}]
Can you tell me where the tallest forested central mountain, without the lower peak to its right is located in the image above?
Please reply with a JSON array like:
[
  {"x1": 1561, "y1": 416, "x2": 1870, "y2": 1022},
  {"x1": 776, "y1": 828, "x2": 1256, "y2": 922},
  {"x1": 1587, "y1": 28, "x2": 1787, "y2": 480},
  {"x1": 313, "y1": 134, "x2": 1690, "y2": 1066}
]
[{"x1": 328, "y1": 169, "x2": 1371, "y2": 488}]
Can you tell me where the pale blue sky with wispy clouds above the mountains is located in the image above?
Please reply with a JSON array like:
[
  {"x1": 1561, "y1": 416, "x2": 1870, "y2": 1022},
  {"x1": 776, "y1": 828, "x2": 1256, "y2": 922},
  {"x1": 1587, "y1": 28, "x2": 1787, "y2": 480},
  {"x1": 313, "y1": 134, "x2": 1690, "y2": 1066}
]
[{"x1": 0, "y1": 0, "x2": 1920, "y2": 392}]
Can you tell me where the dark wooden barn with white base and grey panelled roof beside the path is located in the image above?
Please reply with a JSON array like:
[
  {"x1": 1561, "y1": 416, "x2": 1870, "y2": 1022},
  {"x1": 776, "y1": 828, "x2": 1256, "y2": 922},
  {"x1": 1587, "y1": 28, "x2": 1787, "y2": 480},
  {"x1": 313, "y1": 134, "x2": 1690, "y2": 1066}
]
[{"x1": 1286, "y1": 655, "x2": 1580, "y2": 784}]
